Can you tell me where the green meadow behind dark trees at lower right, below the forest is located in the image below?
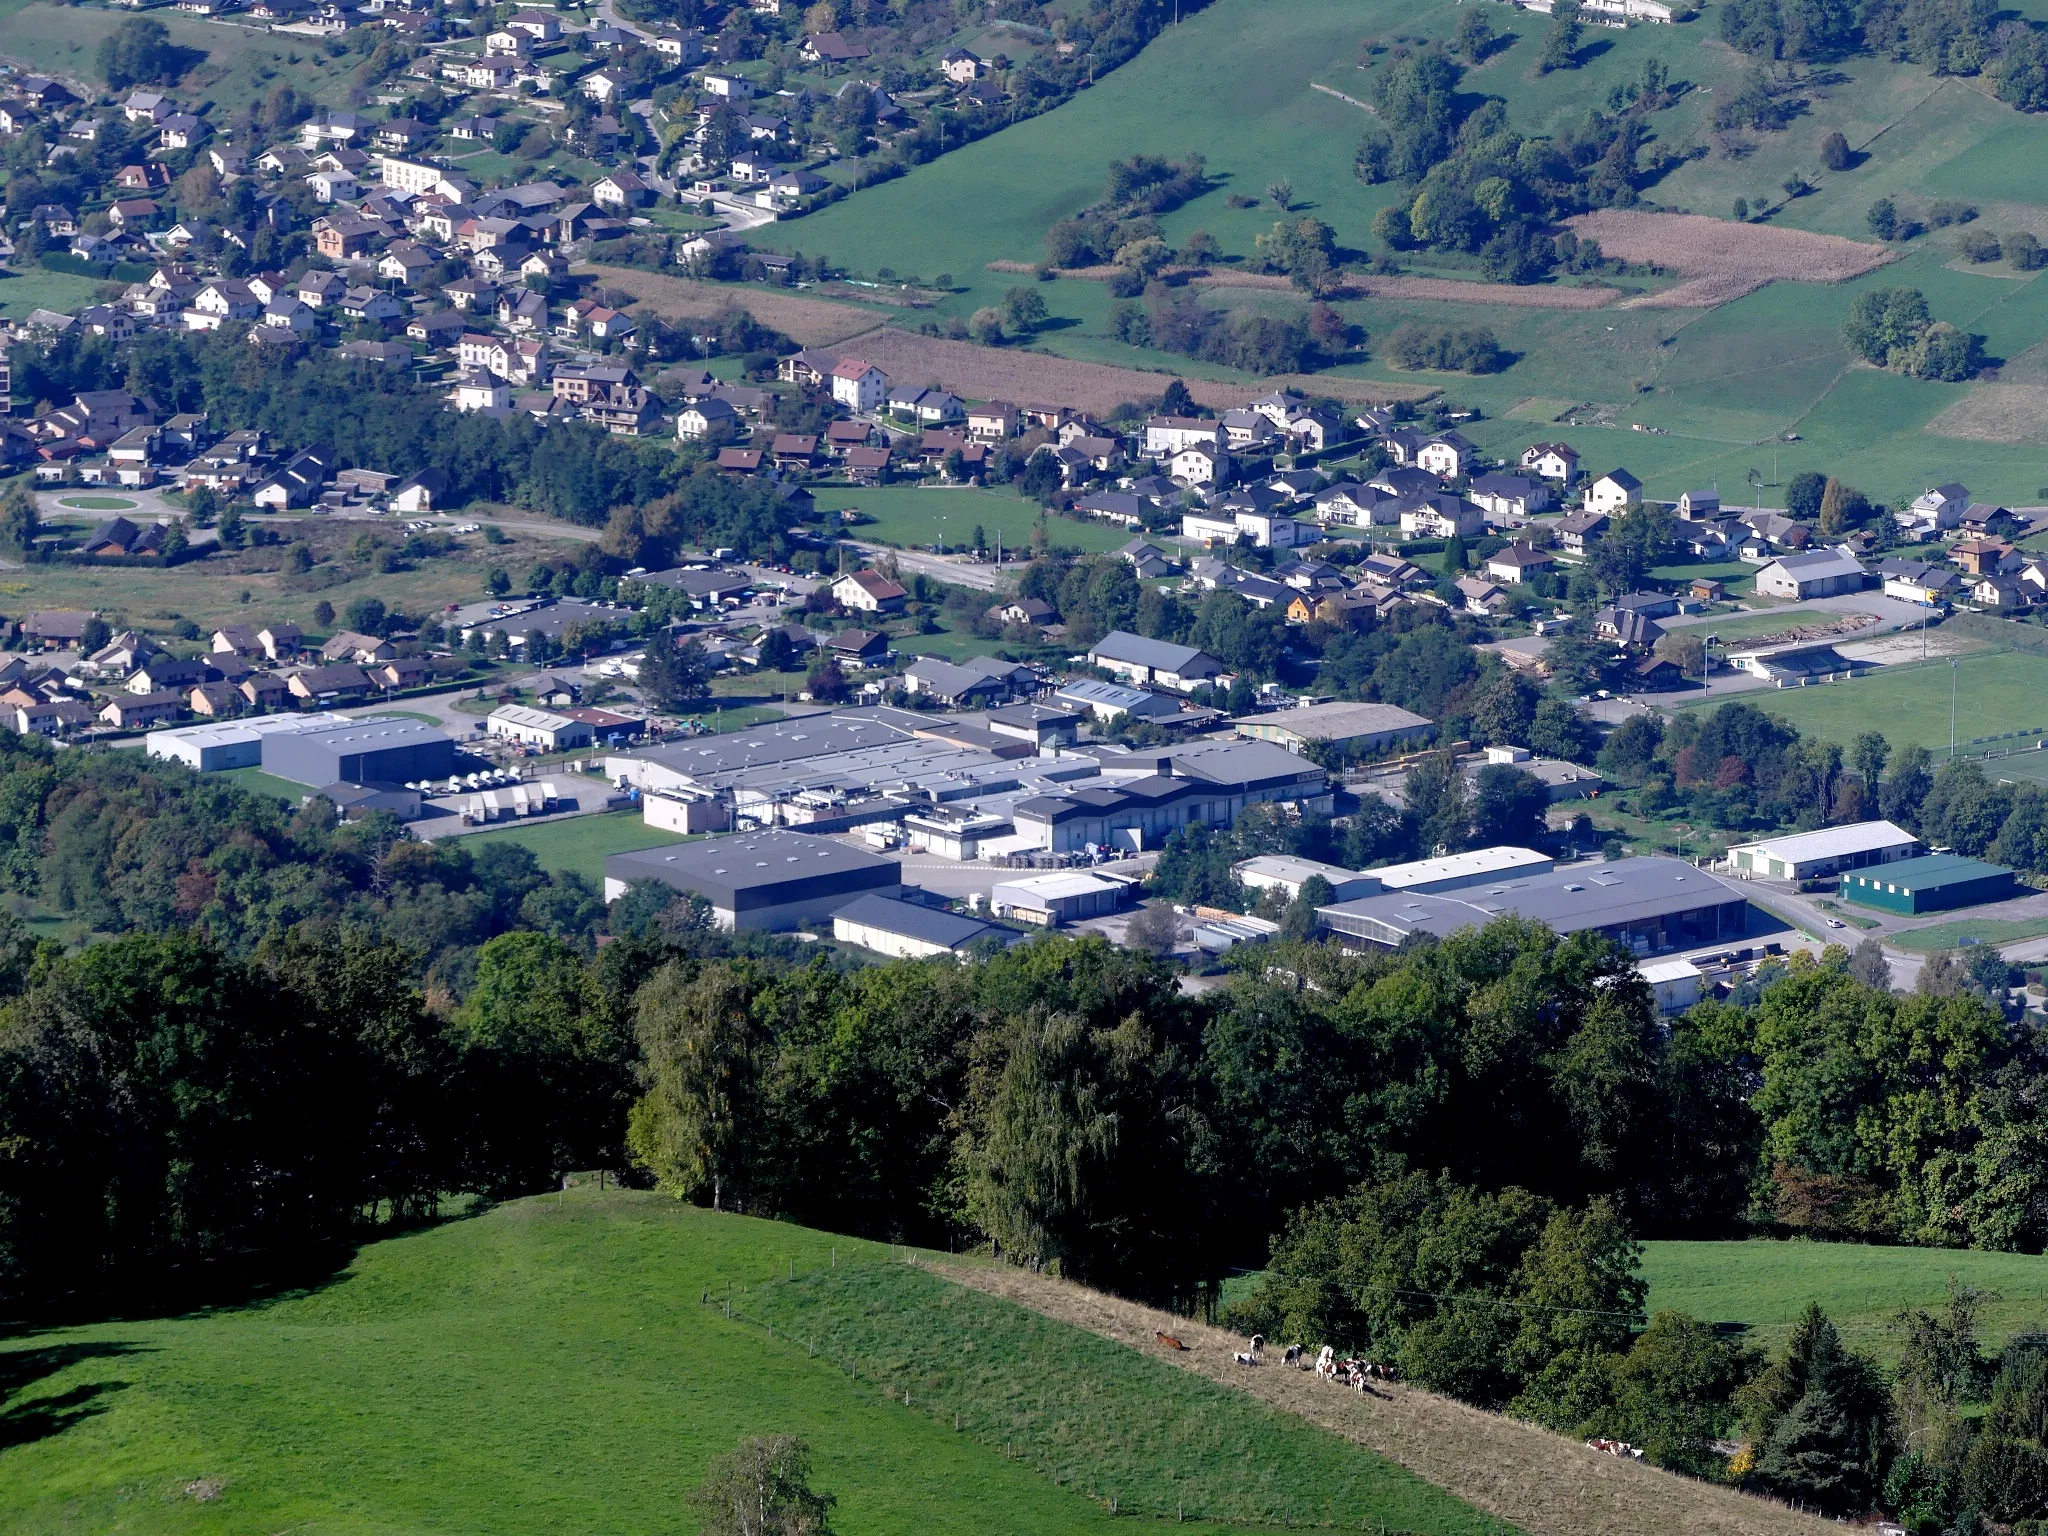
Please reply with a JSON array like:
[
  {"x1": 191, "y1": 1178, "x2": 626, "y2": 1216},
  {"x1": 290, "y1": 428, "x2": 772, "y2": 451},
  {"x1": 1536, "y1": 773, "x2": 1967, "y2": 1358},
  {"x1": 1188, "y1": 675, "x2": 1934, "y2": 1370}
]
[{"x1": 1642, "y1": 1239, "x2": 2048, "y2": 1358}]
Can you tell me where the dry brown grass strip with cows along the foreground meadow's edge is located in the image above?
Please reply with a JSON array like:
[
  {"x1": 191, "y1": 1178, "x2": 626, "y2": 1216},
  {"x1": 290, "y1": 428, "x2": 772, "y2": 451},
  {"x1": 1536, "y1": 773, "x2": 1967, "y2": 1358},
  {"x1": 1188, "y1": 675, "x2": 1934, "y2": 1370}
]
[{"x1": 932, "y1": 1264, "x2": 1837, "y2": 1536}]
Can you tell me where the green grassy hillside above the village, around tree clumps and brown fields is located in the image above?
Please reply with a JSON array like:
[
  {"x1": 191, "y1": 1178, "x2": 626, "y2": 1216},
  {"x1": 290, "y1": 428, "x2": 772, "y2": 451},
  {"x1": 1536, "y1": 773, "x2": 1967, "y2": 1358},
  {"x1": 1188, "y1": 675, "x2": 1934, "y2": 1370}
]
[{"x1": 776, "y1": 0, "x2": 2048, "y2": 504}]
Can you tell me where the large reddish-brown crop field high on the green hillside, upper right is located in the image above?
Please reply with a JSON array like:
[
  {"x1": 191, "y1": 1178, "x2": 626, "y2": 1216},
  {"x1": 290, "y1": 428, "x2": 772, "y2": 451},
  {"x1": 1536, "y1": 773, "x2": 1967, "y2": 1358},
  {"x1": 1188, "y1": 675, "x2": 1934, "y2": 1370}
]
[{"x1": 1565, "y1": 209, "x2": 1894, "y2": 309}]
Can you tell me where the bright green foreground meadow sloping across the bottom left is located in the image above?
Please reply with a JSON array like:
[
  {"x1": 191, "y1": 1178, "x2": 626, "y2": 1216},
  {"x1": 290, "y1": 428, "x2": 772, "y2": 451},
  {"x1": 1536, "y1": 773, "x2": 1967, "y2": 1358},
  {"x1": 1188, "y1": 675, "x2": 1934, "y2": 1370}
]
[{"x1": 0, "y1": 1188, "x2": 1507, "y2": 1536}]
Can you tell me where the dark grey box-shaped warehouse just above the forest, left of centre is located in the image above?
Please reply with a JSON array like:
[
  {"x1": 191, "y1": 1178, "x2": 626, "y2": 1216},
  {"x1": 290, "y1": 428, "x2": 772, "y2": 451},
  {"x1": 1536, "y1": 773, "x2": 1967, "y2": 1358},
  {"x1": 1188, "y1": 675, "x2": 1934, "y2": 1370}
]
[{"x1": 604, "y1": 829, "x2": 903, "y2": 930}]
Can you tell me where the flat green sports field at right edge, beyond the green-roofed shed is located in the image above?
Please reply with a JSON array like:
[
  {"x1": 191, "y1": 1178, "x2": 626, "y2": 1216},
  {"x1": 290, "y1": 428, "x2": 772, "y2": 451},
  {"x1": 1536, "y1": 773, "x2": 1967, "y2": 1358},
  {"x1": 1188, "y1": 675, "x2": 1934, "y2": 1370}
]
[{"x1": 1692, "y1": 651, "x2": 2048, "y2": 768}]
